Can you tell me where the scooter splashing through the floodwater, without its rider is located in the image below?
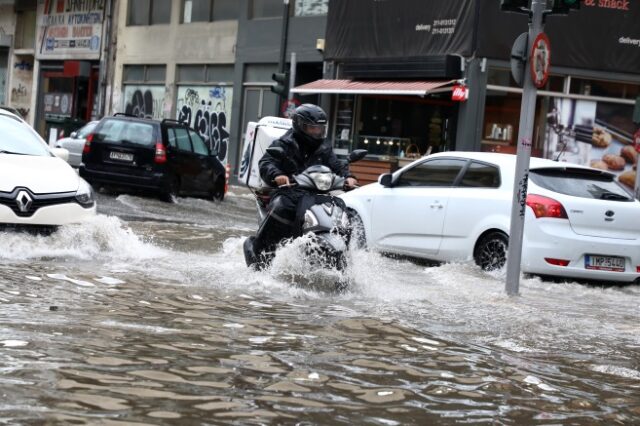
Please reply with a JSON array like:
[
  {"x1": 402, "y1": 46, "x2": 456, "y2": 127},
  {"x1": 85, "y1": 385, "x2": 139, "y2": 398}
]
[{"x1": 243, "y1": 147, "x2": 367, "y2": 271}]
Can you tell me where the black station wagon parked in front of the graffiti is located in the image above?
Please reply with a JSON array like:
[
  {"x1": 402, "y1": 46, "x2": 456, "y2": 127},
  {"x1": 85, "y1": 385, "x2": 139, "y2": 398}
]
[{"x1": 80, "y1": 114, "x2": 226, "y2": 201}]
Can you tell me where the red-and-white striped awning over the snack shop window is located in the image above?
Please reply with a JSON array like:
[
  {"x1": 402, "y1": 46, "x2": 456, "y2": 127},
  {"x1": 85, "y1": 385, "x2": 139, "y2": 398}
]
[{"x1": 291, "y1": 80, "x2": 456, "y2": 96}]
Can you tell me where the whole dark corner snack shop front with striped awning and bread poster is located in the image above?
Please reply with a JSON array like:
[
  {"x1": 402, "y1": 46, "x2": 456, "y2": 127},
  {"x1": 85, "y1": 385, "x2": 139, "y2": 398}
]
[{"x1": 295, "y1": 0, "x2": 640, "y2": 186}]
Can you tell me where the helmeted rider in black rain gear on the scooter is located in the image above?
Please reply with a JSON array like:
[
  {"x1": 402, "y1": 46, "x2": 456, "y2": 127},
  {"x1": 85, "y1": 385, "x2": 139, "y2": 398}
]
[{"x1": 253, "y1": 104, "x2": 358, "y2": 257}]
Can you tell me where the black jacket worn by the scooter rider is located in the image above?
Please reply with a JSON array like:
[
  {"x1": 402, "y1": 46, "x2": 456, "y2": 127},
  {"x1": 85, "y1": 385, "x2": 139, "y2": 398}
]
[{"x1": 258, "y1": 130, "x2": 353, "y2": 185}]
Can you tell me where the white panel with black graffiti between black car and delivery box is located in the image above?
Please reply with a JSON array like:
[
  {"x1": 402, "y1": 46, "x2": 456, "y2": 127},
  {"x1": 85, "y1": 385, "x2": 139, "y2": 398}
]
[{"x1": 176, "y1": 86, "x2": 233, "y2": 162}]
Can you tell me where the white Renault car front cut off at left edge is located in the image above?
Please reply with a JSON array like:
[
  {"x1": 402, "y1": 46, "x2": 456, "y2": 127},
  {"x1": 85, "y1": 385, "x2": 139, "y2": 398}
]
[{"x1": 0, "y1": 110, "x2": 96, "y2": 227}]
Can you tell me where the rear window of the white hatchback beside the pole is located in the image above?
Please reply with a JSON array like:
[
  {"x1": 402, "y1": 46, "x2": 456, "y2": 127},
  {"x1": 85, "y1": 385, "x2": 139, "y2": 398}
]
[{"x1": 529, "y1": 168, "x2": 633, "y2": 201}]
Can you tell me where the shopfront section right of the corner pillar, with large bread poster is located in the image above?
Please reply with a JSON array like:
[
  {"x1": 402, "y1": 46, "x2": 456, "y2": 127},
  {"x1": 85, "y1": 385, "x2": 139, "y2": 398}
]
[{"x1": 478, "y1": 2, "x2": 640, "y2": 188}]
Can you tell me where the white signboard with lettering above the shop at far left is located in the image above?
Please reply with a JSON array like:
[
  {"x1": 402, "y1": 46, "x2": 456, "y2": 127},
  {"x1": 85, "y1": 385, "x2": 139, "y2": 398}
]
[{"x1": 36, "y1": 0, "x2": 105, "y2": 59}]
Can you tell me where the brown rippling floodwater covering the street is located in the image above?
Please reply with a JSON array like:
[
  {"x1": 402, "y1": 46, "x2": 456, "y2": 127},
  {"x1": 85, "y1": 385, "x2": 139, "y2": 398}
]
[{"x1": 0, "y1": 188, "x2": 640, "y2": 426}]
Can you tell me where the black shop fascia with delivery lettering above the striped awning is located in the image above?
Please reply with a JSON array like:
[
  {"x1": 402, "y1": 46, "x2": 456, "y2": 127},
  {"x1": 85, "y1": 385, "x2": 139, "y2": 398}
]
[{"x1": 324, "y1": 0, "x2": 476, "y2": 61}]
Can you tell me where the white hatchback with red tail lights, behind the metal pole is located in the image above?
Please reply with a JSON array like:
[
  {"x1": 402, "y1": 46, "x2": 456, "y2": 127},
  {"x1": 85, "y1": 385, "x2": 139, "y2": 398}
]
[{"x1": 342, "y1": 152, "x2": 640, "y2": 282}]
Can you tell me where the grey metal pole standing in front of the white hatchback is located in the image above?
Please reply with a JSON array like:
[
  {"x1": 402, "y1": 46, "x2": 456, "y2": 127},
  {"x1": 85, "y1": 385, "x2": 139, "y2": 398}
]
[{"x1": 505, "y1": 0, "x2": 546, "y2": 296}]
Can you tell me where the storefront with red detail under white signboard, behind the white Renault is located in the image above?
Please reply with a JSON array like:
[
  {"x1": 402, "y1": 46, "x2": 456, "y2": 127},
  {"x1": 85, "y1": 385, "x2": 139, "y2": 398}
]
[{"x1": 34, "y1": 0, "x2": 104, "y2": 143}]
